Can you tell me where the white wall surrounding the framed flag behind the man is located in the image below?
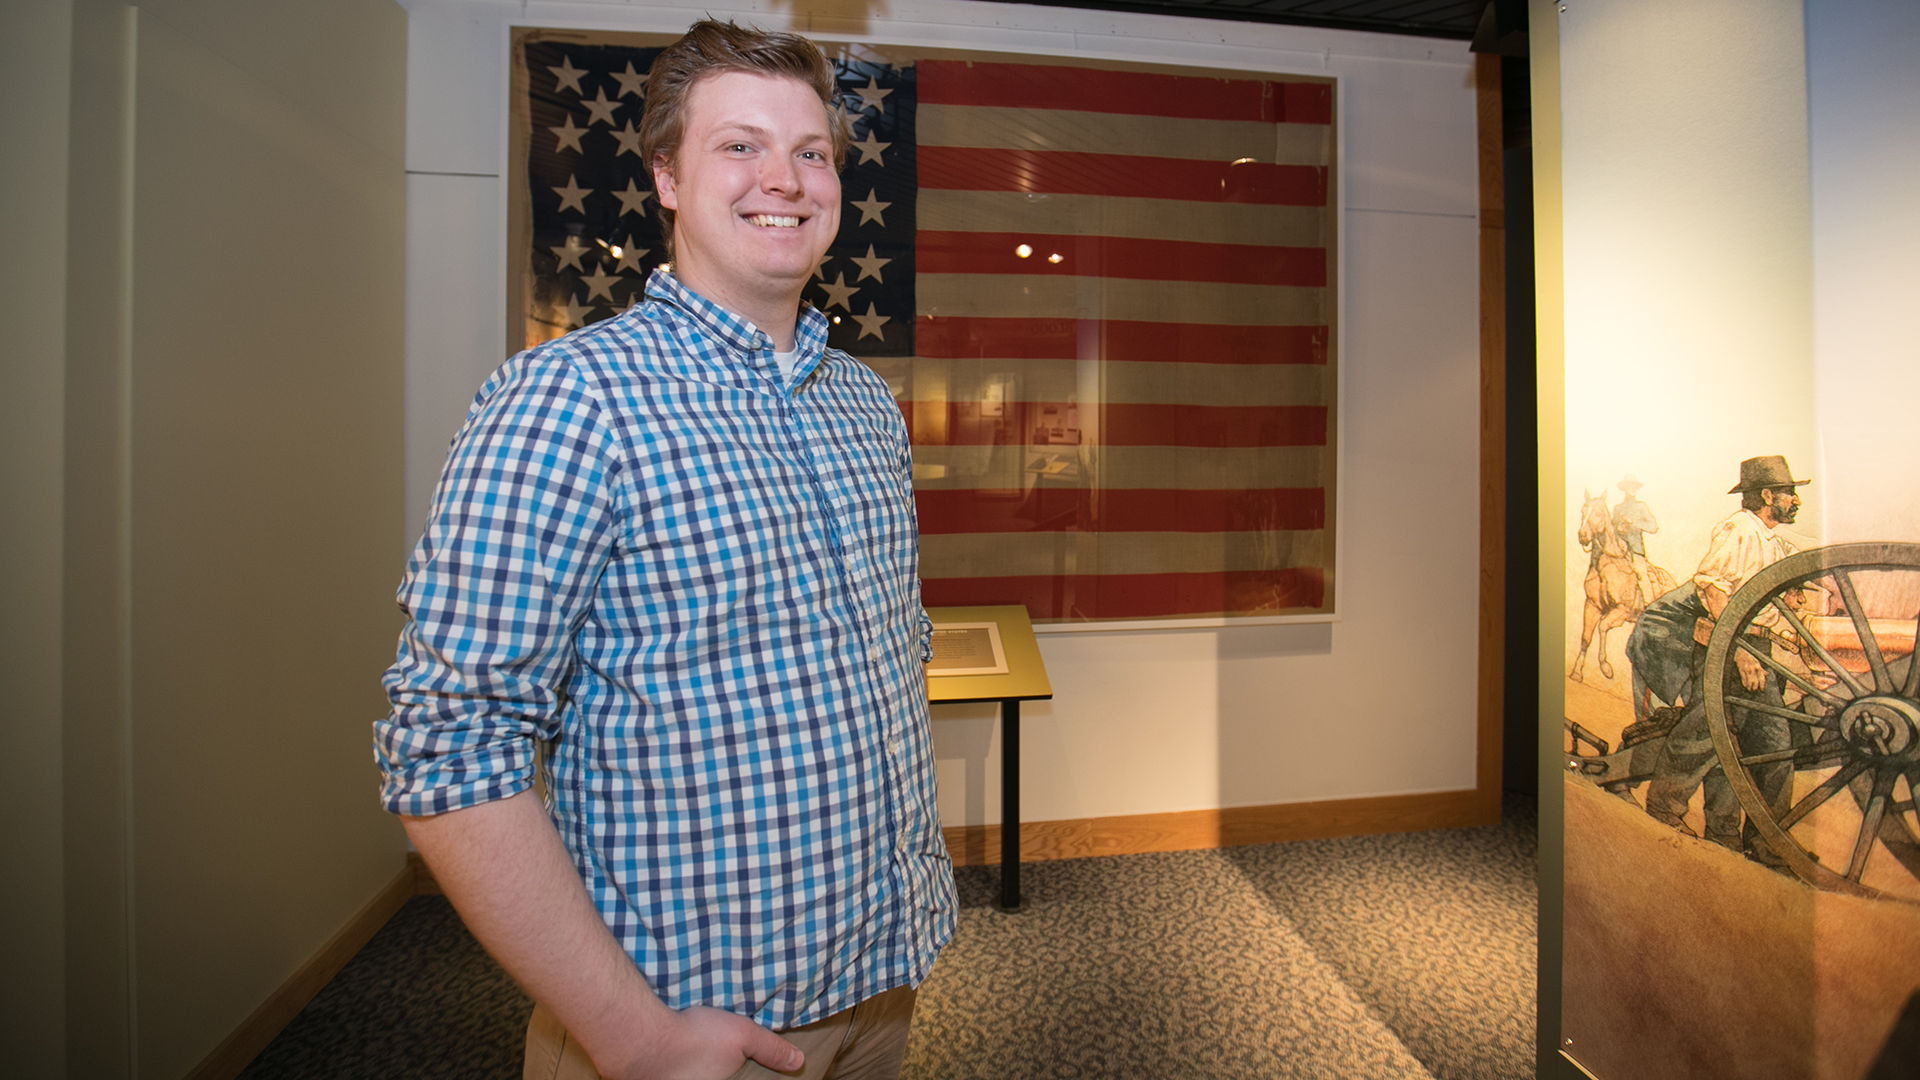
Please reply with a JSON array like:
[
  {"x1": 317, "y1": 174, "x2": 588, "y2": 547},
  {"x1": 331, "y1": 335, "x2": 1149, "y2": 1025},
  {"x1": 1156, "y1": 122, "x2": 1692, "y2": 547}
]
[{"x1": 401, "y1": 0, "x2": 1478, "y2": 824}]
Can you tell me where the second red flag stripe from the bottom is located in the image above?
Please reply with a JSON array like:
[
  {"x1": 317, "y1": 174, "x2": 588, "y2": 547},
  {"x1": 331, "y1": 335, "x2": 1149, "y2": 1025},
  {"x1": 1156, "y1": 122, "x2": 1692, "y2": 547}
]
[{"x1": 914, "y1": 488, "x2": 1327, "y2": 536}]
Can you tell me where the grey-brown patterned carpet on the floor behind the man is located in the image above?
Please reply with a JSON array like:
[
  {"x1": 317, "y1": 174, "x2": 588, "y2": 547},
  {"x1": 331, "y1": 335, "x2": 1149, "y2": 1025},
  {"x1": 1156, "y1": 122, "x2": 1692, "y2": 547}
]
[{"x1": 242, "y1": 798, "x2": 1538, "y2": 1080}]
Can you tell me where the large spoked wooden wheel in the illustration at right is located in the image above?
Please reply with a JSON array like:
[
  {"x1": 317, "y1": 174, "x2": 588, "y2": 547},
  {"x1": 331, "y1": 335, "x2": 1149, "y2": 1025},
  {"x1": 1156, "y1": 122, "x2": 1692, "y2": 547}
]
[{"x1": 1705, "y1": 544, "x2": 1920, "y2": 899}]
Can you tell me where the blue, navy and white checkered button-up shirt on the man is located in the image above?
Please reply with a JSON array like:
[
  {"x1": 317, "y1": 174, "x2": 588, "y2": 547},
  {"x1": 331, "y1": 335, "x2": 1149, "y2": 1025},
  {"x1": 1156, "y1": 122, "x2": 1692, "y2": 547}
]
[{"x1": 374, "y1": 271, "x2": 954, "y2": 1030}]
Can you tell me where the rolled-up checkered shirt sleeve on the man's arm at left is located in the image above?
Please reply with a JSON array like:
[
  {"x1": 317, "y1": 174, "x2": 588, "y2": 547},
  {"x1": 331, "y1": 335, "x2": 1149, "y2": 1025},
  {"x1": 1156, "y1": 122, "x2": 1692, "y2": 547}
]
[{"x1": 372, "y1": 350, "x2": 618, "y2": 817}]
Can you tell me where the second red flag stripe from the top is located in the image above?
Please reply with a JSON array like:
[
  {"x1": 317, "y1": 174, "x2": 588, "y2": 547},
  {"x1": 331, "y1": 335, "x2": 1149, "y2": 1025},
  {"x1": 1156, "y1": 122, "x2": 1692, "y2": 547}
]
[{"x1": 920, "y1": 144, "x2": 1327, "y2": 206}]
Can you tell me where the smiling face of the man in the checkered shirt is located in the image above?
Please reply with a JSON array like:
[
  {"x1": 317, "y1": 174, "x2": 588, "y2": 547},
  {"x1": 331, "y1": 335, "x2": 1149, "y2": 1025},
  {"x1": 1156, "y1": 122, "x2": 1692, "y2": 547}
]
[{"x1": 653, "y1": 71, "x2": 841, "y2": 313}]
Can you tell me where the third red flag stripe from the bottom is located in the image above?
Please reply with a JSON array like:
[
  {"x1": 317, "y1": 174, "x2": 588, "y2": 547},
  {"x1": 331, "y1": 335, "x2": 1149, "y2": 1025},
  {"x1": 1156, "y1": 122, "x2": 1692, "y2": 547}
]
[{"x1": 900, "y1": 400, "x2": 1327, "y2": 448}]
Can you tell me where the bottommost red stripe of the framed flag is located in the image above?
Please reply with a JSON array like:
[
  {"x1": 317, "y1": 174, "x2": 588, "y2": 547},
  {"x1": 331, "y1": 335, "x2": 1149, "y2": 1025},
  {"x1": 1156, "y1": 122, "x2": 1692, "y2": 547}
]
[{"x1": 920, "y1": 567, "x2": 1327, "y2": 619}]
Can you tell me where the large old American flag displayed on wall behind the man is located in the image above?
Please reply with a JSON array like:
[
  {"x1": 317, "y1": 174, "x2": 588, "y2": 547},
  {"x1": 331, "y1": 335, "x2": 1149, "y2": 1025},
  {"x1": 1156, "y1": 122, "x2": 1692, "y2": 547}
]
[{"x1": 524, "y1": 42, "x2": 1334, "y2": 623}]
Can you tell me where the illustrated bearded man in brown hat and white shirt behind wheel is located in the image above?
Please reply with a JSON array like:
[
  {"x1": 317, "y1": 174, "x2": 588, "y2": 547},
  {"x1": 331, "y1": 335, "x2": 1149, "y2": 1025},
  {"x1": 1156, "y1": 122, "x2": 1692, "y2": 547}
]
[{"x1": 1647, "y1": 454, "x2": 1812, "y2": 865}]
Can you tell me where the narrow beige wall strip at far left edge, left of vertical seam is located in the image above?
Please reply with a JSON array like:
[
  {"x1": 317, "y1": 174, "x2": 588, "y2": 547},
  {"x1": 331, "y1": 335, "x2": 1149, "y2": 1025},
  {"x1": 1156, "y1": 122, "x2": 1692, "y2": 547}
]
[{"x1": 0, "y1": 2, "x2": 73, "y2": 1076}]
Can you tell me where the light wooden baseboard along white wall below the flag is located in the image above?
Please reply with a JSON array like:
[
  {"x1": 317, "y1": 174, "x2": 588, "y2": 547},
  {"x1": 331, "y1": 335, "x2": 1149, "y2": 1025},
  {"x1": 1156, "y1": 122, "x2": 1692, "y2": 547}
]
[{"x1": 941, "y1": 776, "x2": 1500, "y2": 867}]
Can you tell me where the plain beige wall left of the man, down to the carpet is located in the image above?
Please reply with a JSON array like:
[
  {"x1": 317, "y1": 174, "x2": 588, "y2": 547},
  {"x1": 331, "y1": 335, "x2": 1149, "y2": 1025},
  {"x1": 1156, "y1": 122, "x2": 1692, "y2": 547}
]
[{"x1": 0, "y1": 0, "x2": 405, "y2": 1078}]
